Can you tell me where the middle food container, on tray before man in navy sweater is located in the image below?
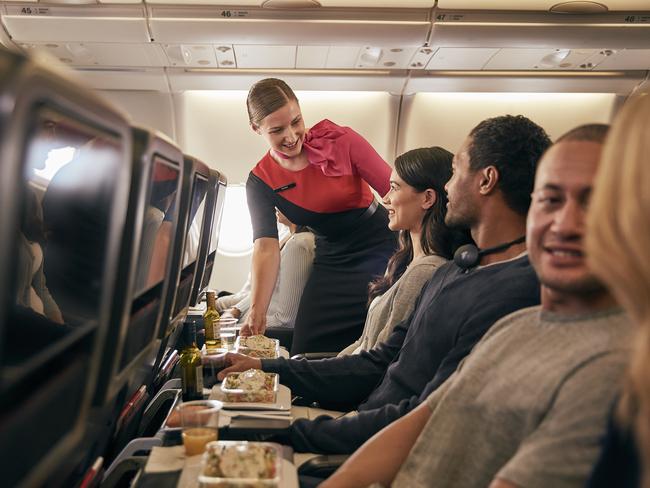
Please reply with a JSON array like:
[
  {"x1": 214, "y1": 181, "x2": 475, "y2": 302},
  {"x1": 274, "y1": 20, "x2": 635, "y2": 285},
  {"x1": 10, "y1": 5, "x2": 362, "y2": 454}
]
[{"x1": 221, "y1": 369, "x2": 279, "y2": 403}]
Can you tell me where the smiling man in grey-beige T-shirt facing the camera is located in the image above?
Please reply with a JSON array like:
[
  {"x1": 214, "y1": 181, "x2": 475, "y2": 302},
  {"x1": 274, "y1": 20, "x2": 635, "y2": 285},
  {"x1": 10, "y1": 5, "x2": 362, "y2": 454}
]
[{"x1": 322, "y1": 125, "x2": 633, "y2": 488}]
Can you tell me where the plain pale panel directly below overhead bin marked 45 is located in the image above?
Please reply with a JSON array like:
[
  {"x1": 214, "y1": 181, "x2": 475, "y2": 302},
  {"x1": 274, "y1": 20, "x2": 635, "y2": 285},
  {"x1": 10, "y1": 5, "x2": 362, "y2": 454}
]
[{"x1": 21, "y1": 42, "x2": 168, "y2": 67}]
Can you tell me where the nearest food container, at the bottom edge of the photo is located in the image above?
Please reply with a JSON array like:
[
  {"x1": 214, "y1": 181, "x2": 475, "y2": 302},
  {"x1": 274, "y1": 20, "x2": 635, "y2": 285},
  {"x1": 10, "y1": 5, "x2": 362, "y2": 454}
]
[{"x1": 199, "y1": 441, "x2": 282, "y2": 488}]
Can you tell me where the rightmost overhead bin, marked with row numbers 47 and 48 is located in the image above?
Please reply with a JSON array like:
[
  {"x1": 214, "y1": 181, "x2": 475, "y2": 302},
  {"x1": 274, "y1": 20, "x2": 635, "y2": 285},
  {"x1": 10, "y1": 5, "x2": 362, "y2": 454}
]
[{"x1": 430, "y1": 10, "x2": 650, "y2": 49}]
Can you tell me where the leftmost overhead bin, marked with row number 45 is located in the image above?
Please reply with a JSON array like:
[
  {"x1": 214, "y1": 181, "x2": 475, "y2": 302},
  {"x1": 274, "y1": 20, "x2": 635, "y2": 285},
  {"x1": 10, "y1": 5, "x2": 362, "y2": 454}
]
[{"x1": 2, "y1": 3, "x2": 150, "y2": 43}]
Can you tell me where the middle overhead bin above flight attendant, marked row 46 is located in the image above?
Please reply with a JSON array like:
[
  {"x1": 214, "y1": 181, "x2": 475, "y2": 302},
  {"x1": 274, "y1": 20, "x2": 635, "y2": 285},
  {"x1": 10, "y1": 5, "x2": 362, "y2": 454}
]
[{"x1": 148, "y1": 5, "x2": 431, "y2": 47}]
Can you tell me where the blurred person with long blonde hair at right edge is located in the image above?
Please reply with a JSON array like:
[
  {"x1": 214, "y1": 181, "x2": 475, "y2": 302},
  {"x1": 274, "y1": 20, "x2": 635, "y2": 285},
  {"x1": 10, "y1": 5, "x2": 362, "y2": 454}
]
[{"x1": 587, "y1": 94, "x2": 650, "y2": 488}]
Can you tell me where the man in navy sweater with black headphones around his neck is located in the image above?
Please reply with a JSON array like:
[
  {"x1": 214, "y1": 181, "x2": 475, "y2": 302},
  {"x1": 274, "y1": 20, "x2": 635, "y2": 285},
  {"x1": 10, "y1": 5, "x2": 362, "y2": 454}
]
[{"x1": 220, "y1": 115, "x2": 550, "y2": 453}]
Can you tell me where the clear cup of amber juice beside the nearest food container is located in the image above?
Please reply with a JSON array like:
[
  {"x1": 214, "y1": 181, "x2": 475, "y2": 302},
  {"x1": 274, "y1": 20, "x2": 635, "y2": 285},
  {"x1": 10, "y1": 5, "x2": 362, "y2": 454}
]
[{"x1": 176, "y1": 400, "x2": 223, "y2": 456}]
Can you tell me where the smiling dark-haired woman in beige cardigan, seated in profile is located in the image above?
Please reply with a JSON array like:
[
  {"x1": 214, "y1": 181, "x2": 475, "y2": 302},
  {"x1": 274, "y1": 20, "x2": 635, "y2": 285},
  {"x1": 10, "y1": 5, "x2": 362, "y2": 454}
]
[{"x1": 339, "y1": 147, "x2": 471, "y2": 356}]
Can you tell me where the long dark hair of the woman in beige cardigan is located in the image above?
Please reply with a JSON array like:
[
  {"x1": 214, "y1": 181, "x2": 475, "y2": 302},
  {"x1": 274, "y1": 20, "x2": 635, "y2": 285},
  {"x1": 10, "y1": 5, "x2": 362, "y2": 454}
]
[{"x1": 368, "y1": 146, "x2": 472, "y2": 303}]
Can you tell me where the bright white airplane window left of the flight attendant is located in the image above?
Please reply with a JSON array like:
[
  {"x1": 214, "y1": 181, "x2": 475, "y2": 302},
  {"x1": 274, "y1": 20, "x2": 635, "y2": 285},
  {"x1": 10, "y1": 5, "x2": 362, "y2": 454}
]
[{"x1": 218, "y1": 185, "x2": 253, "y2": 257}]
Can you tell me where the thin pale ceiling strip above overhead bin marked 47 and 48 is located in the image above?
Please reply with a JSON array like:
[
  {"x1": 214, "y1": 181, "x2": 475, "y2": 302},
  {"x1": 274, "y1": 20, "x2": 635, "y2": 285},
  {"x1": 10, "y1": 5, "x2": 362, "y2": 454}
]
[{"x1": 438, "y1": 0, "x2": 650, "y2": 11}]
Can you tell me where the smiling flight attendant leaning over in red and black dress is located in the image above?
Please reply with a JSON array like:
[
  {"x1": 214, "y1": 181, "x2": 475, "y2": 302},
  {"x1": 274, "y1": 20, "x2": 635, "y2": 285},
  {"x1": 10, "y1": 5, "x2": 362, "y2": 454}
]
[{"x1": 243, "y1": 78, "x2": 396, "y2": 354}]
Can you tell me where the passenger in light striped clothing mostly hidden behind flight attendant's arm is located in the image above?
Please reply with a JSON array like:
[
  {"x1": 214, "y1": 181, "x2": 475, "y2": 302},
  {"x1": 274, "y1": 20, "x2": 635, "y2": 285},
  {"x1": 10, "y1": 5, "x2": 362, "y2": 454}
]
[{"x1": 217, "y1": 210, "x2": 314, "y2": 335}]
